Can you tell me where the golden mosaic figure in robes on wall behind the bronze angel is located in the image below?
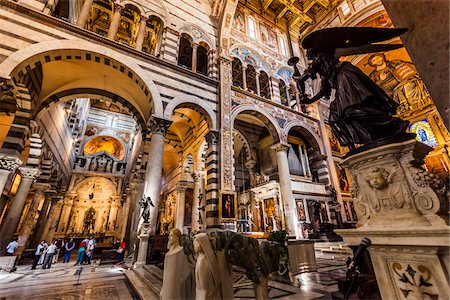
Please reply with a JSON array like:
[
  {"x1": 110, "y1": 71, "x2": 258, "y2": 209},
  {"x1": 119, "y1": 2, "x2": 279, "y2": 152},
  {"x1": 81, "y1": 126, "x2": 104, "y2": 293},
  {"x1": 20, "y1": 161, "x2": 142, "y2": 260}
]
[{"x1": 368, "y1": 53, "x2": 431, "y2": 114}]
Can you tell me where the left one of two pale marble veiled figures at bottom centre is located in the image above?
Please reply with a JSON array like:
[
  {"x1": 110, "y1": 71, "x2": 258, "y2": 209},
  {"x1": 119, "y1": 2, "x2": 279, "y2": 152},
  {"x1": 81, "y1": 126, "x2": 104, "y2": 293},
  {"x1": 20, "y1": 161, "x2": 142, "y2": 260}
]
[{"x1": 159, "y1": 228, "x2": 195, "y2": 300}]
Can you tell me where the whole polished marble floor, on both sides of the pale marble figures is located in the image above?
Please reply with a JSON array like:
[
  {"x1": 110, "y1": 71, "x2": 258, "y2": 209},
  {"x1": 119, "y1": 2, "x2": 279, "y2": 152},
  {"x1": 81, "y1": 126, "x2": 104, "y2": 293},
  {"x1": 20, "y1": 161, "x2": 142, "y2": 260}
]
[{"x1": 0, "y1": 252, "x2": 346, "y2": 300}]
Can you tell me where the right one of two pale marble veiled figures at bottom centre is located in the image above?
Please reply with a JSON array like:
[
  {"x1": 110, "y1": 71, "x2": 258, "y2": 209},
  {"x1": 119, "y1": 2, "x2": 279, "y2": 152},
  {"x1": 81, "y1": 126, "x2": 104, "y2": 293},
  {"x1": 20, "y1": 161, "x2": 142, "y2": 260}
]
[{"x1": 194, "y1": 233, "x2": 233, "y2": 300}]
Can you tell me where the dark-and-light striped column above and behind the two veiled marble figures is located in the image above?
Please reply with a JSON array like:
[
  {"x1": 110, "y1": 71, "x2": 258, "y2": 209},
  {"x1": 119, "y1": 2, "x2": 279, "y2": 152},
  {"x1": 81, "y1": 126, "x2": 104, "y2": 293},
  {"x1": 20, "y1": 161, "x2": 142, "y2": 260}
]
[{"x1": 205, "y1": 131, "x2": 220, "y2": 228}]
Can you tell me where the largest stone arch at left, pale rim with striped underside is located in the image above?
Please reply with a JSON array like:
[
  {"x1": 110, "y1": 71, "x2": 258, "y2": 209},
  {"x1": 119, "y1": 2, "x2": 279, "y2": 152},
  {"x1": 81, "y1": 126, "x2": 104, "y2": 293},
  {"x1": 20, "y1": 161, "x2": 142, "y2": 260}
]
[{"x1": 0, "y1": 40, "x2": 163, "y2": 120}]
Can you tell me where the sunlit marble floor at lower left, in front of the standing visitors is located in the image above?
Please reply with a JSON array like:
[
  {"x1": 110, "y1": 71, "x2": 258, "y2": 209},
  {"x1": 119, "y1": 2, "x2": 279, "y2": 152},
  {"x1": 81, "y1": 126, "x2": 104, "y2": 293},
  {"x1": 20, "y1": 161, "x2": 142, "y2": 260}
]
[{"x1": 0, "y1": 262, "x2": 139, "y2": 300}]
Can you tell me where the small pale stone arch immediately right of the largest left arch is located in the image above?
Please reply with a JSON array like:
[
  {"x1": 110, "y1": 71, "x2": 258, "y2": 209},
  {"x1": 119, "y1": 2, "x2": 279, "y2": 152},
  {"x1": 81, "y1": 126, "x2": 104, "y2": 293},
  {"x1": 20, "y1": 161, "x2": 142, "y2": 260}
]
[{"x1": 164, "y1": 95, "x2": 218, "y2": 131}]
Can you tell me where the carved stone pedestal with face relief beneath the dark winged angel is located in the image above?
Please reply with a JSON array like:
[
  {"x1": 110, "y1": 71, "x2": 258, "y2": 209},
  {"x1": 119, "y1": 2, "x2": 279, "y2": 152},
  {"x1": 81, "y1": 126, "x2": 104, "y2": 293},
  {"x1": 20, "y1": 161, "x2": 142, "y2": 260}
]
[{"x1": 336, "y1": 140, "x2": 450, "y2": 299}]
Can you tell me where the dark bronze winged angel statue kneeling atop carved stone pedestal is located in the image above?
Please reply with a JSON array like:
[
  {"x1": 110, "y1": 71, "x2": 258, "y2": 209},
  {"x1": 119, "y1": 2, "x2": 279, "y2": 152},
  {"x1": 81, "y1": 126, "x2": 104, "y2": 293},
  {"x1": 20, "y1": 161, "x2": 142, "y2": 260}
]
[{"x1": 288, "y1": 27, "x2": 409, "y2": 150}]
